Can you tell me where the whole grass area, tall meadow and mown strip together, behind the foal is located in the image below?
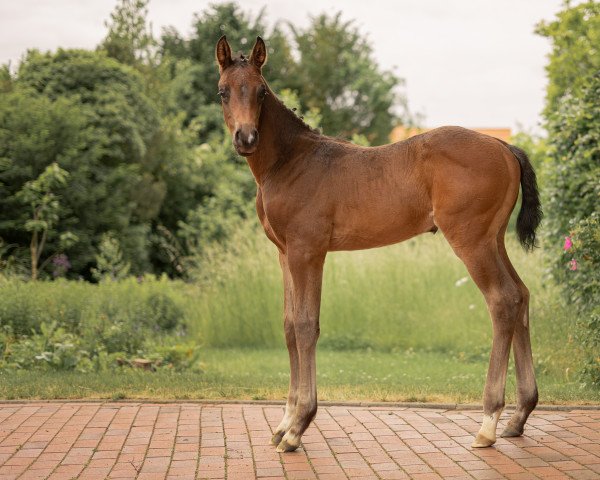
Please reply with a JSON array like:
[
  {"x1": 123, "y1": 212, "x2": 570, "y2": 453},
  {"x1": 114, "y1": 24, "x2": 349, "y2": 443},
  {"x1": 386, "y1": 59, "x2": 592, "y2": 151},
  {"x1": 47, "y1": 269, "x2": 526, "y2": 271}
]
[{"x1": 0, "y1": 230, "x2": 600, "y2": 403}]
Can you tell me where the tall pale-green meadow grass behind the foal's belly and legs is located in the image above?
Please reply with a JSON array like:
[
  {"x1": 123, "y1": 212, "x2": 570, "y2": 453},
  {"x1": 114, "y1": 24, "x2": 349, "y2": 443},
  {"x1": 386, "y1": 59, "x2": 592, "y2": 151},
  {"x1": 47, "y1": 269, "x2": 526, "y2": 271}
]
[{"x1": 189, "y1": 234, "x2": 582, "y2": 375}]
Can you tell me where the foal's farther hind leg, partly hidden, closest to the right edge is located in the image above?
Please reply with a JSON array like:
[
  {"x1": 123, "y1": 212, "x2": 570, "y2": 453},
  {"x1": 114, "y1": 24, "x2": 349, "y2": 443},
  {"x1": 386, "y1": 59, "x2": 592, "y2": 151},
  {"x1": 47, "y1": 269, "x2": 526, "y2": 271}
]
[{"x1": 498, "y1": 238, "x2": 538, "y2": 437}]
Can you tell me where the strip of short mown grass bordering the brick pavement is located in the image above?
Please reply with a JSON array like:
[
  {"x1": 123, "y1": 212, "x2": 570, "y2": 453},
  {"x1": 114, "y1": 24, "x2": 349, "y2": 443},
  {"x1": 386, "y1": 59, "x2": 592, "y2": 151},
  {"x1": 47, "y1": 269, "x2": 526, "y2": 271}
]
[{"x1": 0, "y1": 346, "x2": 600, "y2": 404}]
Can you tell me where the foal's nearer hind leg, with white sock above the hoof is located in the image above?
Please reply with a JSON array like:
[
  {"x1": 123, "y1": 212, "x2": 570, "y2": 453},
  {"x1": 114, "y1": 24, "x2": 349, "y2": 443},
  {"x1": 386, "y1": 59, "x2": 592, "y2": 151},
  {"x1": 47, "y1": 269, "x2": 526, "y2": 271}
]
[{"x1": 445, "y1": 231, "x2": 523, "y2": 447}]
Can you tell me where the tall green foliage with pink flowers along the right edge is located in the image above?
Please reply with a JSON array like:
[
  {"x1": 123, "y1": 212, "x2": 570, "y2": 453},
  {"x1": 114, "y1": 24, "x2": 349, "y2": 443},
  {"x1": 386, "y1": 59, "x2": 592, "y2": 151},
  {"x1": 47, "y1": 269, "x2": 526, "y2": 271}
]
[{"x1": 539, "y1": 2, "x2": 600, "y2": 385}]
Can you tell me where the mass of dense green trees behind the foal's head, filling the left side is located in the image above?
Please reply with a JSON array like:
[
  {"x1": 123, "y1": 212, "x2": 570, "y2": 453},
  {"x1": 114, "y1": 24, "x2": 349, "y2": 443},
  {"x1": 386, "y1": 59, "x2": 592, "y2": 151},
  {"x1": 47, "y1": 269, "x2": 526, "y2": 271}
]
[{"x1": 0, "y1": 0, "x2": 402, "y2": 281}]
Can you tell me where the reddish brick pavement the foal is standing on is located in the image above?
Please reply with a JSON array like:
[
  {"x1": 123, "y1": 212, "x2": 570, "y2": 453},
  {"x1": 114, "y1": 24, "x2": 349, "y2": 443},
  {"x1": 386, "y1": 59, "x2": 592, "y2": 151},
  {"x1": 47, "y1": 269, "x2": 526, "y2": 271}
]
[{"x1": 0, "y1": 402, "x2": 600, "y2": 480}]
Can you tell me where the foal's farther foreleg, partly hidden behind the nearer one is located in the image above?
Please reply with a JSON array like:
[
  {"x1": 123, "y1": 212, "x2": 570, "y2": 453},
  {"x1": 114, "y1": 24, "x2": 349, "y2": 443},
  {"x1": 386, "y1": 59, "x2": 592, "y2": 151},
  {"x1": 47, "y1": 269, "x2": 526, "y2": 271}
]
[{"x1": 271, "y1": 252, "x2": 298, "y2": 445}]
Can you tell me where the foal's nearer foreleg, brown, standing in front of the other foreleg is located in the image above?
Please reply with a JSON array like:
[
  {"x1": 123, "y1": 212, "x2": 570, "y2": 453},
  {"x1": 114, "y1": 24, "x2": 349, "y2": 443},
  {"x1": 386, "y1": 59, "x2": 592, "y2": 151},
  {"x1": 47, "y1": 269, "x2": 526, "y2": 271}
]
[{"x1": 277, "y1": 246, "x2": 325, "y2": 452}]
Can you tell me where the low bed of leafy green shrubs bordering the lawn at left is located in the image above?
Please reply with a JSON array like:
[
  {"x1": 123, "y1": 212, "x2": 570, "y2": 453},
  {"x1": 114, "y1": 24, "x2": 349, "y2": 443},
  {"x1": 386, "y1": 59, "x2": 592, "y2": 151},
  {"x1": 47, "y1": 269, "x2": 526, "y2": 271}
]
[{"x1": 0, "y1": 276, "x2": 191, "y2": 371}]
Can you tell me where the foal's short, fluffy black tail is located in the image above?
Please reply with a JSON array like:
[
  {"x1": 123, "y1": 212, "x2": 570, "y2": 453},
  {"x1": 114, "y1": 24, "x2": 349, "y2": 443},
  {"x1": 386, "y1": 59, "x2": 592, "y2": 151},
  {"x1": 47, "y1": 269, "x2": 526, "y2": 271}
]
[{"x1": 507, "y1": 145, "x2": 543, "y2": 250}]
